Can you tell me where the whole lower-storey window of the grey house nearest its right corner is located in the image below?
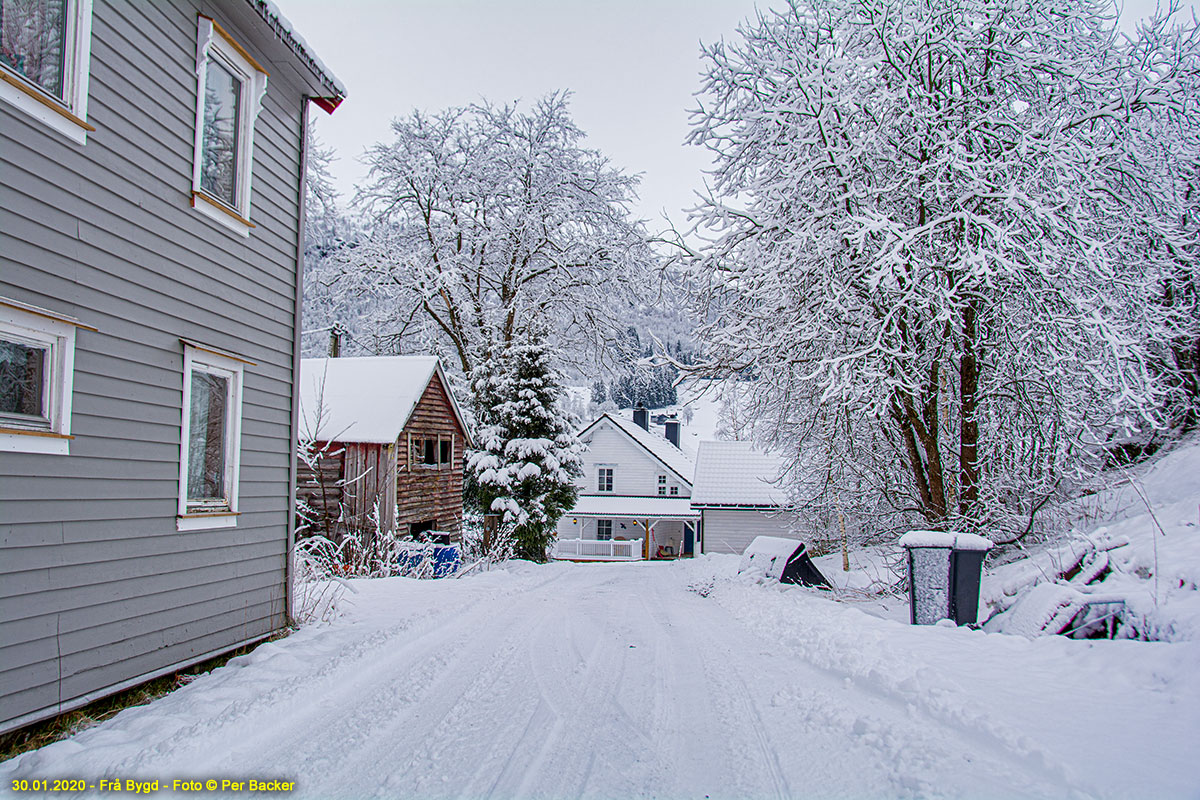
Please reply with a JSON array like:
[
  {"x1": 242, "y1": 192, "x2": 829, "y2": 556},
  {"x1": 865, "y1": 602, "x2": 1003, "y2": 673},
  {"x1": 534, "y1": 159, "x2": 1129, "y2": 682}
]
[{"x1": 178, "y1": 342, "x2": 250, "y2": 530}]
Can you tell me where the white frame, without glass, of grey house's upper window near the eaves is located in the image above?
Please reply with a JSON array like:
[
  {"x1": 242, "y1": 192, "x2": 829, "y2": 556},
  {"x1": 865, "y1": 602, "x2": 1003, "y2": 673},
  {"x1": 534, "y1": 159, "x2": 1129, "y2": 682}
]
[{"x1": 192, "y1": 14, "x2": 268, "y2": 236}]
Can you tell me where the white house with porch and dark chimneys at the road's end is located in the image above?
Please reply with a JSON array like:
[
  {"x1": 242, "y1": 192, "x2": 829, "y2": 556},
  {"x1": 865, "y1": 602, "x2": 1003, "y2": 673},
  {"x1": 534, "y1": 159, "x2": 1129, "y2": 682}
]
[{"x1": 554, "y1": 409, "x2": 700, "y2": 560}]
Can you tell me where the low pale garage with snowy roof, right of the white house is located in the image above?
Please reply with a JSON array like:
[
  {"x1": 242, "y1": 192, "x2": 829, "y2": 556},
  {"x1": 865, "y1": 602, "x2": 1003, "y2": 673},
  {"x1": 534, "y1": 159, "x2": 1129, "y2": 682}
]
[{"x1": 691, "y1": 441, "x2": 798, "y2": 554}]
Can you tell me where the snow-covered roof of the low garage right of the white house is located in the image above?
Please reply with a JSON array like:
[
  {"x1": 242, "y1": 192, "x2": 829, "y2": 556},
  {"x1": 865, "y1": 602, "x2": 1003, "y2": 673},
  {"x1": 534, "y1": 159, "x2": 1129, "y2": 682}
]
[{"x1": 691, "y1": 441, "x2": 787, "y2": 509}]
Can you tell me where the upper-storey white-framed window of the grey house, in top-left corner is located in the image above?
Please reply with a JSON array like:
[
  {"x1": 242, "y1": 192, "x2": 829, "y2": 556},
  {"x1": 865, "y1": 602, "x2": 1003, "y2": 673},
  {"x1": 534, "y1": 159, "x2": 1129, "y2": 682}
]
[{"x1": 0, "y1": 0, "x2": 96, "y2": 144}]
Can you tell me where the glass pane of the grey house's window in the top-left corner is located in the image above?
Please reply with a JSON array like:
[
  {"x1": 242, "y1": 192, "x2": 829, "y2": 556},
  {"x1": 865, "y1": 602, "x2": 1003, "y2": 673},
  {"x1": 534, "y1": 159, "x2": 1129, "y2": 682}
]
[{"x1": 0, "y1": 0, "x2": 67, "y2": 100}]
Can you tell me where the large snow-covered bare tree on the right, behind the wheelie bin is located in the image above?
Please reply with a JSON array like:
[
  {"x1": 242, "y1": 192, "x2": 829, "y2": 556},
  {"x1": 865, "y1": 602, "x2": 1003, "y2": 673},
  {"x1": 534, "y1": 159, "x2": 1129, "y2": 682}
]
[{"x1": 690, "y1": 0, "x2": 1200, "y2": 537}]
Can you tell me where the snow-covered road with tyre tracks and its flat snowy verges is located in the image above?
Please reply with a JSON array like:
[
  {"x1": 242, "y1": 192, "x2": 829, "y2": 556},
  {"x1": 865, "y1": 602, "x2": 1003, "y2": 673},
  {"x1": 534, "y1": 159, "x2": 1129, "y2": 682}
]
[{"x1": 0, "y1": 559, "x2": 1200, "y2": 798}]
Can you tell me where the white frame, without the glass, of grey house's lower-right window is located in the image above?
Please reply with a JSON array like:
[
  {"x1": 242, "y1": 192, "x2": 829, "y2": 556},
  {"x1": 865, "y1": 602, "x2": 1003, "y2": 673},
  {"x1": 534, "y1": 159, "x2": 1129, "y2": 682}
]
[{"x1": 175, "y1": 341, "x2": 253, "y2": 530}]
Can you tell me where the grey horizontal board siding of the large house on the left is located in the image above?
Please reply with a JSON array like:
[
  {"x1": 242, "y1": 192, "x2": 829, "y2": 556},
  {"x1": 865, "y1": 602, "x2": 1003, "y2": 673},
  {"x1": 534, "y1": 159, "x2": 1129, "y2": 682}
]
[{"x1": 0, "y1": 0, "x2": 301, "y2": 729}]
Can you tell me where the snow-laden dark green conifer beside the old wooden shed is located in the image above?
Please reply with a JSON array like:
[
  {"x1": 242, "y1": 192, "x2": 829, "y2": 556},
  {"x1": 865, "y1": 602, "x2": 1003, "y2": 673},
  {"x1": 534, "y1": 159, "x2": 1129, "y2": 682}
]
[{"x1": 467, "y1": 337, "x2": 582, "y2": 561}]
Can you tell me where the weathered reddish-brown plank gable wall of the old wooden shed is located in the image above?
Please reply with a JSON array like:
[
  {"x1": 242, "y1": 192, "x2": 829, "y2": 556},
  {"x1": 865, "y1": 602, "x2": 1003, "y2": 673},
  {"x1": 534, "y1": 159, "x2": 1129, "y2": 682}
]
[{"x1": 396, "y1": 373, "x2": 464, "y2": 536}]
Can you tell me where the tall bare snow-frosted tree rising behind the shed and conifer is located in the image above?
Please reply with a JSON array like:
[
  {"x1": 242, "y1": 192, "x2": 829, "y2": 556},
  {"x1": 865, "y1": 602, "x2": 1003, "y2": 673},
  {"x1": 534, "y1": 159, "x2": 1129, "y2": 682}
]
[{"x1": 353, "y1": 94, "x2": 653, "y2": 375}]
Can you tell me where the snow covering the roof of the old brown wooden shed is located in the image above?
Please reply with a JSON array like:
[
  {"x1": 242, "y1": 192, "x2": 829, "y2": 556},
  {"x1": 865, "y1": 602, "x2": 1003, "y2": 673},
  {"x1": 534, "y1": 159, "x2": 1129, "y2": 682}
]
[{"x1": 300, "y1": 355, "x2": 467, "y2": 444}]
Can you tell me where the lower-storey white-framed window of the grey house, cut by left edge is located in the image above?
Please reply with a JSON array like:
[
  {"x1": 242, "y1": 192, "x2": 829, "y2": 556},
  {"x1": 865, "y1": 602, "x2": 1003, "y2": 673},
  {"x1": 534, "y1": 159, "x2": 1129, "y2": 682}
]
[{"x1": 0, "y1": 297, "x2": 80, "y2": 456}]
